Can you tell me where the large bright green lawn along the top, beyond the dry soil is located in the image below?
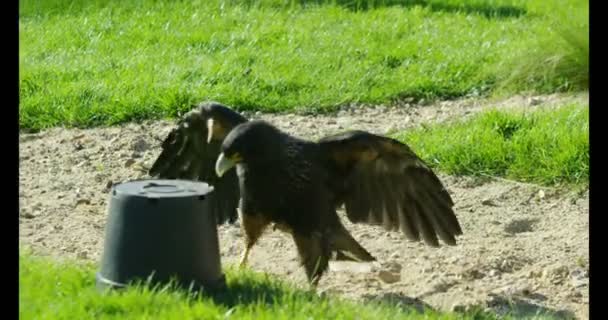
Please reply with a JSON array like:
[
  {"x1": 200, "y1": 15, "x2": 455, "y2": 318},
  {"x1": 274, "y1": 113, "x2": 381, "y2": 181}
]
[{"x1": 19, "y1": 0, "x2": 586, "y2": 129}]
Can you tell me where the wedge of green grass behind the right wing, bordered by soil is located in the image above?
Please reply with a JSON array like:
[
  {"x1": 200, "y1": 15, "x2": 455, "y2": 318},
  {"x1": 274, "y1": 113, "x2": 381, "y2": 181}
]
[{"x1": 397, "y1": 104, "x2": 589, "y2": 187}]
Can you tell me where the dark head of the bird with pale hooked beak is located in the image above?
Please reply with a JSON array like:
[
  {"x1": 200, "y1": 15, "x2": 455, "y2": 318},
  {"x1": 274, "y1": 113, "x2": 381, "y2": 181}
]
[{"x1": 215, "y1": 120, "x2": 282, "y2": 177}]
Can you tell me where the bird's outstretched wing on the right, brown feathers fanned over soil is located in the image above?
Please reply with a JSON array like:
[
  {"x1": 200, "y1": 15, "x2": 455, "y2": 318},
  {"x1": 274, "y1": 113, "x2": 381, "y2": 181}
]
[{"x1": 319, "y1": 131, "x2": 462, "y2": 247}]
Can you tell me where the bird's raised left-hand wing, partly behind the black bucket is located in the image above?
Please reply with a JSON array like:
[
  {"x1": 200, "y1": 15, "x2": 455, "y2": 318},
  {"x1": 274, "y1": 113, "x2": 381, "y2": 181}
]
[{"x1": 149, "y1": 102, "x2": 247, "y2": 224}]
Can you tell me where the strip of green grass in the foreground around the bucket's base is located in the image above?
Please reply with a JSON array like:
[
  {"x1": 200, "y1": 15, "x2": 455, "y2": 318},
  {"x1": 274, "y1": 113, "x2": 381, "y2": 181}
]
[{"x1": 19, "y1": 251, "x2": 508, "y2": 320}]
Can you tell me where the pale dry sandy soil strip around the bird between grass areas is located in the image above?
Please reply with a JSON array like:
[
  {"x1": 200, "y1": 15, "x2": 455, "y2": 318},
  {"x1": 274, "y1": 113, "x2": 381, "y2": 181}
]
[{"x1": 19, "y1": 94, "x2": 589, "y2": 319}]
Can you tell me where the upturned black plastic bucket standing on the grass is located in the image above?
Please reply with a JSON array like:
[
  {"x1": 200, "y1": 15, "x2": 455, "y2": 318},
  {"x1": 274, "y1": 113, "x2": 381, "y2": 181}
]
[{"x1": 96, "y1": 180, "x2": 225, "y2": 290}]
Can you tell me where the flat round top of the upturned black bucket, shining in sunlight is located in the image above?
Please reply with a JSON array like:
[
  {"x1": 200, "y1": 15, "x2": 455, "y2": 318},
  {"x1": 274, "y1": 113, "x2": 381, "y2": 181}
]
[{"x1": 112, "y1": 179, "x2": 213, "y2": 198}]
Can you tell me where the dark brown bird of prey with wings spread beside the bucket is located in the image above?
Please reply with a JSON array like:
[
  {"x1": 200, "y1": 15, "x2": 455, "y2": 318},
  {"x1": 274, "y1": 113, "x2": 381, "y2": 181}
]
[{"x1": 149, "y1": 102, "x2": 462, "y2": 286}]
